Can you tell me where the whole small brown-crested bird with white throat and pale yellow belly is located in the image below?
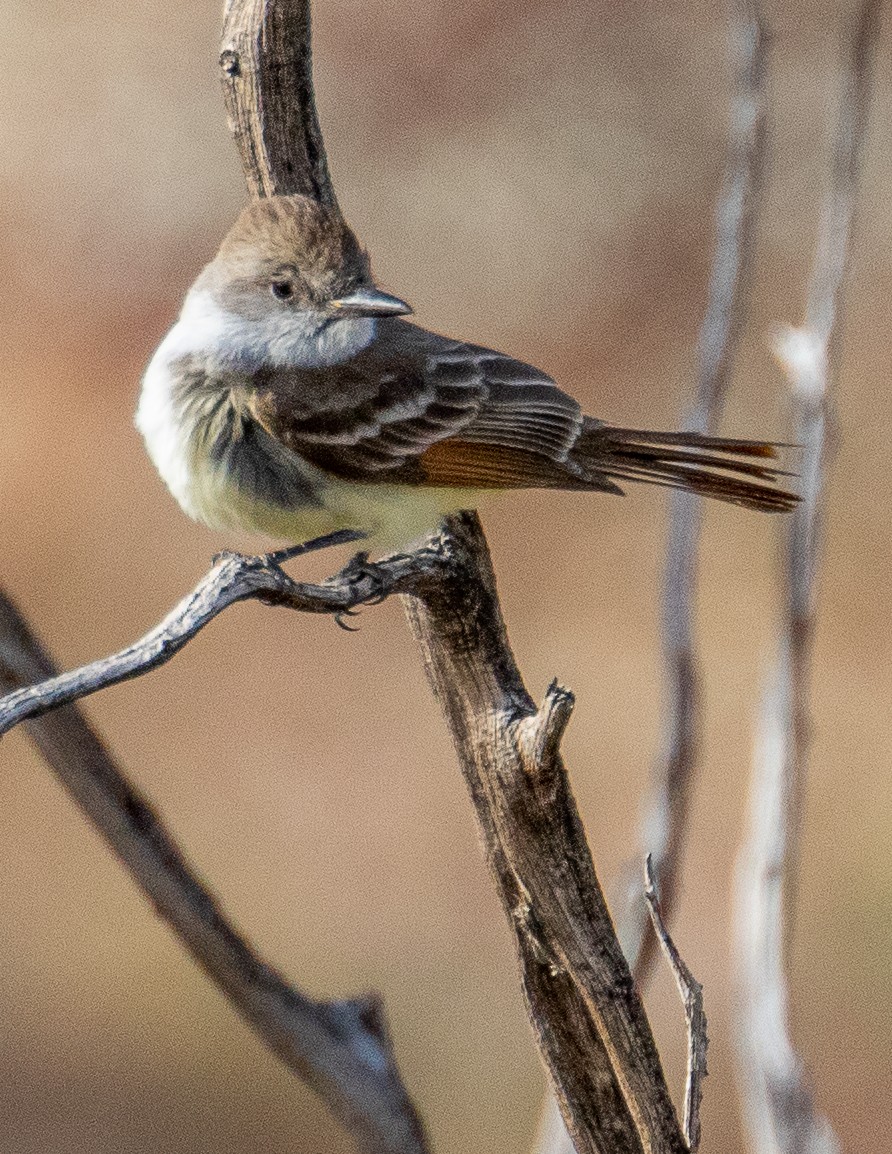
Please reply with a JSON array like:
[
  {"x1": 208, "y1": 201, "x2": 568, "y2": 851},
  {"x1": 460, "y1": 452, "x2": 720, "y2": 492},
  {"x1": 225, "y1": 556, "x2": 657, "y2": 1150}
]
[{"x1": 136, "y1": 196, "x2": 795, "y2": 546}]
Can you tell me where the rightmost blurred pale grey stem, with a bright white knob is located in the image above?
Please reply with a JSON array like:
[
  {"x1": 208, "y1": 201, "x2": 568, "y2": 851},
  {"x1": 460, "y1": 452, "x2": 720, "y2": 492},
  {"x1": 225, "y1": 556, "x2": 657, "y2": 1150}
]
[{"x1": 735, "y1": 0, "x2": 882, "y2": 1154}]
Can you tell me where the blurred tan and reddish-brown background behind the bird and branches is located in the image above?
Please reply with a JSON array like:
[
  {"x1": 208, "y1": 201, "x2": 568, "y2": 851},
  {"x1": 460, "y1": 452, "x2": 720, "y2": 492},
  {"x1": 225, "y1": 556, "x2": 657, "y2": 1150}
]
[{"x1": 0, "y1": 0, "x2": 892, "y2": 1154}]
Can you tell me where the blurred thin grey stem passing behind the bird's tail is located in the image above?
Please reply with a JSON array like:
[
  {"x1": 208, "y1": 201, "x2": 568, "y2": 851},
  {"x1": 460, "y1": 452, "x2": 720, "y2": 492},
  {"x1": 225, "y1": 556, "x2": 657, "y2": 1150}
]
[{"x1": 621, "y1": 0, "x2": 767, "y2": 984}]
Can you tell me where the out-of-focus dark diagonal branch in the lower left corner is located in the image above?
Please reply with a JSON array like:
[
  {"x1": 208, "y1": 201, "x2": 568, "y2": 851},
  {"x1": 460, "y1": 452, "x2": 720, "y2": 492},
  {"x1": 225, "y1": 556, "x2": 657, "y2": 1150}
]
[{"x1": 0, "y1": 586, "x2": 428, "y2": 1154}]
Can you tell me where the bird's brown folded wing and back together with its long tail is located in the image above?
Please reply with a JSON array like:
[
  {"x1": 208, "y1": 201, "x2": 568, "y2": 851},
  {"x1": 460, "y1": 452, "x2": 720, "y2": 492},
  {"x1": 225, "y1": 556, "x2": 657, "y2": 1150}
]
[{"x1": 248, "y1": 321, "x2": 796, "y2": 511}]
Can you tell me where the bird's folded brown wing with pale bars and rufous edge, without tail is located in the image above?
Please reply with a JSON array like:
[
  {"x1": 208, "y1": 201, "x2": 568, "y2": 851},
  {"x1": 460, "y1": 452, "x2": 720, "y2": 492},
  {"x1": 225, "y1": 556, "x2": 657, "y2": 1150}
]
[{"x1": 249, "y1": 321, "x2": 590, "y2": 488}]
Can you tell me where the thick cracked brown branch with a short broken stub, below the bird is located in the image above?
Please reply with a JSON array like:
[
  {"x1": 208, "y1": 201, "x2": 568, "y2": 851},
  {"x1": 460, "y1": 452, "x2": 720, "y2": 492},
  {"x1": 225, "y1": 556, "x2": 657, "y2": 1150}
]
[{"x1": 406, "y1": 514, "x2": 687, "y2": 1154}]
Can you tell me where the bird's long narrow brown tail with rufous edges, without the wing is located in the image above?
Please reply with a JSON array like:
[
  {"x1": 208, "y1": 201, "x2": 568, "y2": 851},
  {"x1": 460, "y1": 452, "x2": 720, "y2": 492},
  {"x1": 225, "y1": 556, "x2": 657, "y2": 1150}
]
[{"x1": 571, "y1": 420, "x2": 799, "y2": 512}]
